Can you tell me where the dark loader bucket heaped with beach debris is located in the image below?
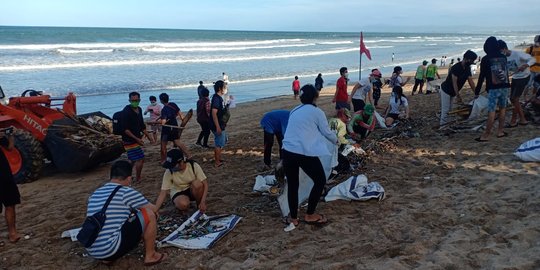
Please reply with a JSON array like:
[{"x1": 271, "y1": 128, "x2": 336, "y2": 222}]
[{"x1": 44, "y1": 112, "x2": 124, "y2": 172}]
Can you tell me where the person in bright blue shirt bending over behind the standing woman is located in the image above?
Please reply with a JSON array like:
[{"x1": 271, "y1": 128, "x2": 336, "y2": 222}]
[{"x1": 261, "y1": 110, "x2": 289, "y2": 169}]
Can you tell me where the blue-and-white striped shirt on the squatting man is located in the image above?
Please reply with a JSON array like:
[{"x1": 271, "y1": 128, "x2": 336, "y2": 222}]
[{"x1": 86, "y1": 183, "x2": 148, "y2": 259}]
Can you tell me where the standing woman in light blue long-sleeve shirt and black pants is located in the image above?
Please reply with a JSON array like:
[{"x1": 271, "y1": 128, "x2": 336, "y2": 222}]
[{"x1": 282, "y1": 84, "x2": 338, "y2": 231}]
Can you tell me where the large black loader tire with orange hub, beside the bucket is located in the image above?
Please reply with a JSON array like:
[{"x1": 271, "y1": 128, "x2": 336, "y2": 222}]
[{"x1": 9, "y1": 130, "x2": 45, "y2": 184}]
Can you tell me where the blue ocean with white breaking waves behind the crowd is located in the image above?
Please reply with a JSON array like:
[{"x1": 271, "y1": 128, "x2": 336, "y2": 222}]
[{"x1": 0, "y1": 26, "x2": 535, "y2": 115}]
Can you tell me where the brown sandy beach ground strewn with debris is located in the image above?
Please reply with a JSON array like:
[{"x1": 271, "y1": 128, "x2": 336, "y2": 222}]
[{"x1": 0, "y1": 68, "x2": 540, "y2": 269}]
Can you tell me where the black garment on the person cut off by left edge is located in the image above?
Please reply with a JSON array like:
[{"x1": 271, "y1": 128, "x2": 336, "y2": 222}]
[{"x1": 0, "y1": 150, "x2": 21, "y2": 213}]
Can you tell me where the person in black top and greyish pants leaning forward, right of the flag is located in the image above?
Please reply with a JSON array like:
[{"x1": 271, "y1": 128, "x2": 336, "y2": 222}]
[{"x1": 439, "y1": 50, "x2": 477, "y2": 126}]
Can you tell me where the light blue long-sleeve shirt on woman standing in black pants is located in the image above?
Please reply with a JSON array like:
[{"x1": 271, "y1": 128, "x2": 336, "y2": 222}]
[{"x1": 283, "y1": 104, "x2": 337, "y2": 157}]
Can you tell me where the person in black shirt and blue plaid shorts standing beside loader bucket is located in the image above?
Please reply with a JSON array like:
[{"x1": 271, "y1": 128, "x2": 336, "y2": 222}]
[{"x1": 120, "y1": 92, "x2": 154, "y2": 181}]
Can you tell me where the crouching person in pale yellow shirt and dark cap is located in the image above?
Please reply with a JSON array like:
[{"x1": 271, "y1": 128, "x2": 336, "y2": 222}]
[{"x1": 156, "y1": 148, "x2": 208, "y2": 213}]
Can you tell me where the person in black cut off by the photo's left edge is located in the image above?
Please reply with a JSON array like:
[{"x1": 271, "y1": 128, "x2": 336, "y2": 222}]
[{"x1": 0, "y1": 128, "x2": 21, "y2": 243}]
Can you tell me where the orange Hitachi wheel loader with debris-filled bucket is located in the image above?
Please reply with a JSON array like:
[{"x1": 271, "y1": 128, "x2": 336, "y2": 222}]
[{"x1": 0, "y1": 87, "x2": 124, "y2": 183}]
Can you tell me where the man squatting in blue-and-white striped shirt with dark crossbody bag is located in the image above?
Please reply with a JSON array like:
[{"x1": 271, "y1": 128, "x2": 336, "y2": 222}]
[{"x1": 86, "y1": 160, "x2": 166, "y2": 266}]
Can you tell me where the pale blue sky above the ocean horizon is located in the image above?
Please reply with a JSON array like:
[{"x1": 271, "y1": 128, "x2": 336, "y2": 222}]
[{"x1": 0, "y1": 0, "x2": 540, "y2": 32}]
